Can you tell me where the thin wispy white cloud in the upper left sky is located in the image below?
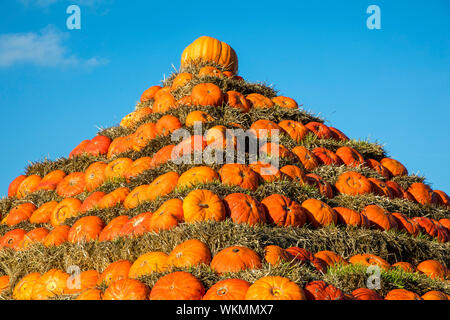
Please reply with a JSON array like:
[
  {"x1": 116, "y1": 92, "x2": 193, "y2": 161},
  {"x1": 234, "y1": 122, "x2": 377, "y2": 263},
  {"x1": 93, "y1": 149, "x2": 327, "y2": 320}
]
[{"x1": 0, "y1": 27, "x2": 107, "y2": 68}]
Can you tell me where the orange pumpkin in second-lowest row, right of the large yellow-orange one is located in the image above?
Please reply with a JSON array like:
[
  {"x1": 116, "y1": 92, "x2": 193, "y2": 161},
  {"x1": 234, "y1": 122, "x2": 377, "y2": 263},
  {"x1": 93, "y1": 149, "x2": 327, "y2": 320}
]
[{"x1": 211, "y1": 246, "x2": 262, "y2": 274}]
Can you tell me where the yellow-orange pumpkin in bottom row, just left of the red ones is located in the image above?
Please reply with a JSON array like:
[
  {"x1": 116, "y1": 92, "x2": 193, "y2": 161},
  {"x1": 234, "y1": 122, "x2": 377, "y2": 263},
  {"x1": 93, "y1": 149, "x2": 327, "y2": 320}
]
[{"x1": 245, "y1": 276, "x2": 306, "y2": 300}]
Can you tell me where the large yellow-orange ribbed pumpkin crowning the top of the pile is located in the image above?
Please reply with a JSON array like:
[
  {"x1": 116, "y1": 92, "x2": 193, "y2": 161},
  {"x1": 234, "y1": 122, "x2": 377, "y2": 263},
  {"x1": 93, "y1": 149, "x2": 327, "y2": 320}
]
[{"x1": 181, "y1": 36, "x2": 238, "y2": 74}]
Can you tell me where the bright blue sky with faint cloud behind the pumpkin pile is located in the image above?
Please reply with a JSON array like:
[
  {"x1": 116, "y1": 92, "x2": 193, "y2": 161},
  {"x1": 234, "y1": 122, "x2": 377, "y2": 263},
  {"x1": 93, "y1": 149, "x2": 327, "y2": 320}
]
[{"x1": 0, "y1": 0, "x2": 450, "y2": 195}]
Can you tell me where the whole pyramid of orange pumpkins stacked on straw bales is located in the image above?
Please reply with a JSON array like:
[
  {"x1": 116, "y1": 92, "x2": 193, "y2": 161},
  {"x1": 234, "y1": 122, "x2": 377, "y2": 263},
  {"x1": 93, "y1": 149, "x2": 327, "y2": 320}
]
[{"x1": 0, "y1": 37, "x2": 450, "y2": 300}]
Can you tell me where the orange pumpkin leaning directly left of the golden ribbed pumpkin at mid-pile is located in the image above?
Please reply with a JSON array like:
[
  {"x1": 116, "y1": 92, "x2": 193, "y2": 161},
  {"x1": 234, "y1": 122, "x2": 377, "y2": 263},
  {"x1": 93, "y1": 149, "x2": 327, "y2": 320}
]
[{"x1": 149, "y1": 199, "x2": 184, "y2": 232}]
